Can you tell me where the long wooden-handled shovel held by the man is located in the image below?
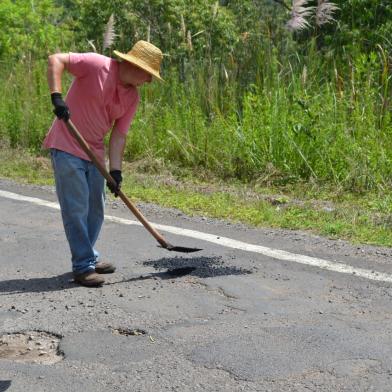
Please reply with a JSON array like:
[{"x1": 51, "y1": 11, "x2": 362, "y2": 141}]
[{"x1": 65, "y1": 120, "x2": 202, "y2": 253}]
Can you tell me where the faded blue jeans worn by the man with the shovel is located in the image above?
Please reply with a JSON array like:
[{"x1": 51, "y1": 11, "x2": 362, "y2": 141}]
[{"x1": 51, "y1": 148, "x2": 105, "y2": 274}]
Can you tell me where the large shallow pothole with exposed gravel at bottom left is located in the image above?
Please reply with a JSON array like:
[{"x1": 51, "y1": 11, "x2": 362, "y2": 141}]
[{"x1": 0, "y1": 331, "x2": 63, "y2": 365}]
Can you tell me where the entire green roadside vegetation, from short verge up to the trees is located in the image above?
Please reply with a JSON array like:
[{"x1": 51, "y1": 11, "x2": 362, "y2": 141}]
[{"x1": 0, "y1": 0, "x2": 392, "y2": 246}]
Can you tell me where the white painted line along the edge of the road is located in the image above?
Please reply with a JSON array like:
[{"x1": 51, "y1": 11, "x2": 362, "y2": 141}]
[{"x1": 0, "y1": 190, "x2": 392, "y2": 283}]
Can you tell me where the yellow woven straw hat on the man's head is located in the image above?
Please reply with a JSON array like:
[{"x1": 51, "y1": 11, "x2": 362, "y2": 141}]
[{"x1": 113, "y1": 41, "x2": 163, "y2": 80}]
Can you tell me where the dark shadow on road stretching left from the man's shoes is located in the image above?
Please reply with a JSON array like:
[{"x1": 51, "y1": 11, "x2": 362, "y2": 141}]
[{"x1": 0, "y1": 272, "x2": 75, "y2": 294}]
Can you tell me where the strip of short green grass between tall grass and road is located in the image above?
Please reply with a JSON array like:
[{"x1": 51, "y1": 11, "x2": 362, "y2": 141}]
[{"x1": 0, "y1": 148, "x2": 392, "y2": 246}]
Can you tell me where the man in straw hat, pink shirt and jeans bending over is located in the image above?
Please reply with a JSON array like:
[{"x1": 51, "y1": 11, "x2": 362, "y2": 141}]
[{"x1": 44, "y1": 41, "x2": 162, "y2": 287}]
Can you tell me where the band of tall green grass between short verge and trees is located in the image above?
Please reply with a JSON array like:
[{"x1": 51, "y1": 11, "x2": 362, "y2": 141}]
[{"x1": 0, "y1": 43, "x2": 392, "y2": 191}]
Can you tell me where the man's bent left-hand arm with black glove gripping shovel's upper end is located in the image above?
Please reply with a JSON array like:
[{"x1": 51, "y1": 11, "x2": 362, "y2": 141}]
[{"x1": 47, "y1": 53, "x2": 70, "y2": 121}]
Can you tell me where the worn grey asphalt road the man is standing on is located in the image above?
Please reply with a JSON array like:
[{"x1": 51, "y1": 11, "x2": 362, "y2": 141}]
[{"x1": 0, "y1": 180, "x2": 392, "y2": 392}]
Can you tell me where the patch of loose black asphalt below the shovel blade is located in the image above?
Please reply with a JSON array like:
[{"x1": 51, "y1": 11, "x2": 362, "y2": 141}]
[{"x1": 143, "y1": 256, "x2": 253, "y2": 278}]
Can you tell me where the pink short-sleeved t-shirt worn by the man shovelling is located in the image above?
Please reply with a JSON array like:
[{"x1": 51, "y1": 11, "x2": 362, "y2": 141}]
[{"x1": 43, "y1": 53, "x2": 139, "y2": 162}]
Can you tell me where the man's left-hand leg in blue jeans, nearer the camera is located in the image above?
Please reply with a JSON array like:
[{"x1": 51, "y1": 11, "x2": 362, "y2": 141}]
[{"x1": 52, "y1": 149, "x2": 95, "y2": 274}]
